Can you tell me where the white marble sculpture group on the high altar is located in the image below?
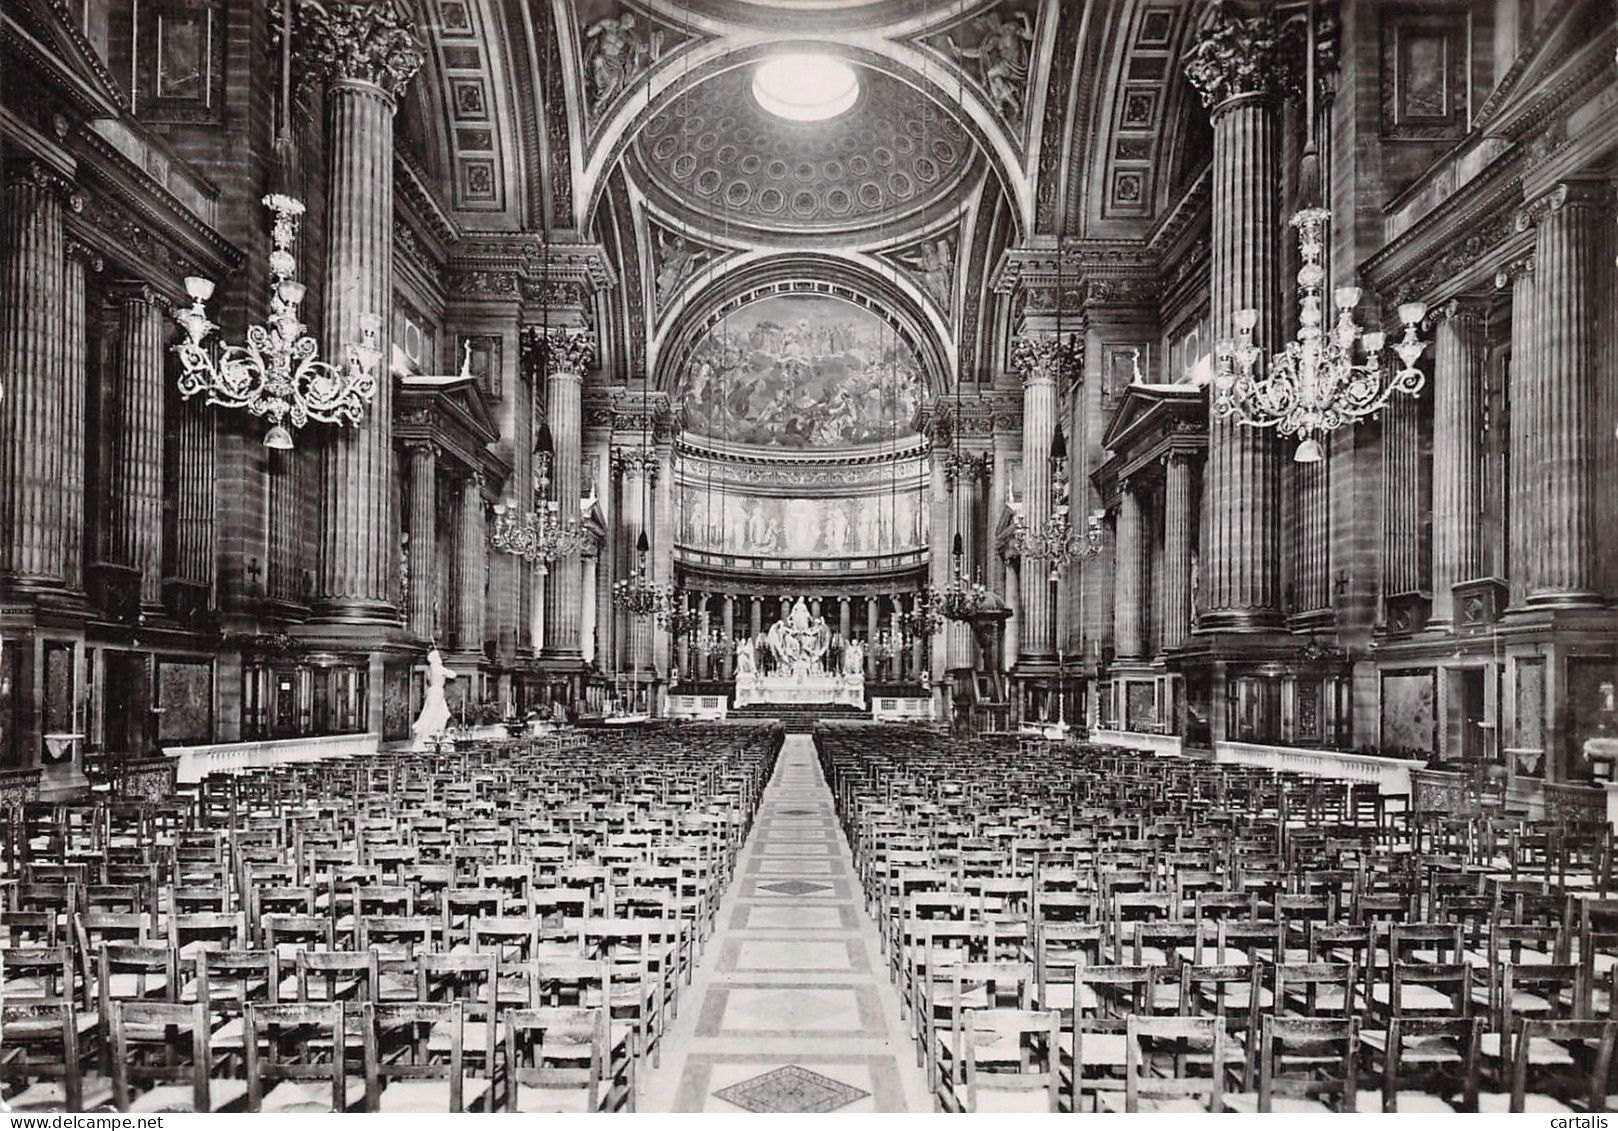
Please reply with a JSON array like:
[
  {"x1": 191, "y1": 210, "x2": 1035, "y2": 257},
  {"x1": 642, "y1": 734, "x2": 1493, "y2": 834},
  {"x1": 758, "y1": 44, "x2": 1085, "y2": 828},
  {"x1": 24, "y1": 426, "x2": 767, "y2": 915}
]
[{"x1": 736, "y1": 597, "x2": 866, "y2": 707}]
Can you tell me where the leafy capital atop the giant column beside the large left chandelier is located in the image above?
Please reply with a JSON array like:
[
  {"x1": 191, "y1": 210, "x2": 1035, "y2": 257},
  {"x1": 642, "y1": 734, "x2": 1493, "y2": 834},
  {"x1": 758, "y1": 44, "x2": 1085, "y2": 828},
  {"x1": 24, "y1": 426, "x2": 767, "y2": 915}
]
[{"x1": 289, "y1": 0, "x2": 422, "y2": 97}]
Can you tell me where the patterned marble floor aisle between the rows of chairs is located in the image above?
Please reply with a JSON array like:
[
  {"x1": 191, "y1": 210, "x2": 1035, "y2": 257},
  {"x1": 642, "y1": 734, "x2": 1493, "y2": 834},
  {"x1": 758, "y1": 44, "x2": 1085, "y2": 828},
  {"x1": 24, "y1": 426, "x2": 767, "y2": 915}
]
[{"x1": 639, "y1": 735, "x2": 932, "y2": 1112}]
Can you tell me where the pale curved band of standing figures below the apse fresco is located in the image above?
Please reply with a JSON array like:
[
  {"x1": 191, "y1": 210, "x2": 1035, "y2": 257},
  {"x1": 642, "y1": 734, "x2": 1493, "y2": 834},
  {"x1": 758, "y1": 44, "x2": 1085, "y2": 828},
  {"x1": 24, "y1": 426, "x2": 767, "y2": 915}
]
[{"x1": 680, "y1": 484, "x2": 927, "y2": 558}]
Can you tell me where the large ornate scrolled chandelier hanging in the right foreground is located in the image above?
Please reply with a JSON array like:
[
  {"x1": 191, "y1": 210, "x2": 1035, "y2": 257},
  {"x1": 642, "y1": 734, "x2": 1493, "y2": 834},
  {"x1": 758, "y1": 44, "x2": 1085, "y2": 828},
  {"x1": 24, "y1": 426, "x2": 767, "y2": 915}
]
[{"x1": 1214, "y1": 209, "x2": 1427, "y2": 463}]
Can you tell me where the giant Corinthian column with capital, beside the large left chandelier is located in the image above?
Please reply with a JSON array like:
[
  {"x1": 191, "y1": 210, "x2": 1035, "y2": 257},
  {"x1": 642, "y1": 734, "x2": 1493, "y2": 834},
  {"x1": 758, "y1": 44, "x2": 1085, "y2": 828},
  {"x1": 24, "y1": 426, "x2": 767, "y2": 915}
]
[{"x1": 298, "y1": 5, "x2": 421, "y2": 625}]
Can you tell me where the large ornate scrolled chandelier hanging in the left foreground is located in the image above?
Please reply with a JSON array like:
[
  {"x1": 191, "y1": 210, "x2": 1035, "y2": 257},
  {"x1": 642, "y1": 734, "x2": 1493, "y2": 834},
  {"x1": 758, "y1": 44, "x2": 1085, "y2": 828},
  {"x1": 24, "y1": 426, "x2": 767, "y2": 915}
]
[{"x1": 175, "y1": 193, "x2": 382, "y2": 450}]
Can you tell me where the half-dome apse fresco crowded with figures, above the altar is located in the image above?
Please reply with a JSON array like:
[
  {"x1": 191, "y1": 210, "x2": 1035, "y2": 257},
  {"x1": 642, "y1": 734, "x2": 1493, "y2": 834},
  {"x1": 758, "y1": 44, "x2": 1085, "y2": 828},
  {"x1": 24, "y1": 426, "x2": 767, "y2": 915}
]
[{"x1": 681, "y1": 294, "x2": 922, "y2": 450}]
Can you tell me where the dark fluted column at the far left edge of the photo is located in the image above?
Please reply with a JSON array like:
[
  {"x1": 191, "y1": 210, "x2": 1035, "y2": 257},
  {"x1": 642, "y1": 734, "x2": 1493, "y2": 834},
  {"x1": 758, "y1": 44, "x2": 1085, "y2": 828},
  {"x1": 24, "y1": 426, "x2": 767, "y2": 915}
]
[{"x1": 0, "y1": 165, "x2": 70, "y2": 589}]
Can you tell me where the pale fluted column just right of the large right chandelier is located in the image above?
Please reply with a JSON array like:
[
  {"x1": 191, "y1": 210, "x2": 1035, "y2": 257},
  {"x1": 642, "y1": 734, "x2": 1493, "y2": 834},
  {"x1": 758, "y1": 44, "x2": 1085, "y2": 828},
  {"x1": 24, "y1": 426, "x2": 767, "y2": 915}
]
[{"x1": 1432, "y1": 299, "x2": 1485, "y2": 623}]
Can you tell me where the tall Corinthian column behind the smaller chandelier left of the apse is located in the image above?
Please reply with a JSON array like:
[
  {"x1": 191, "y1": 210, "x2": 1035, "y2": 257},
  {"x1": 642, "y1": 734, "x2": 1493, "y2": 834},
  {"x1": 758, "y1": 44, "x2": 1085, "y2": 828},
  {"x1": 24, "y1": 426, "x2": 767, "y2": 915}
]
[{"x1": 542, "y1": 330, "x2": 595, "y2": 660}]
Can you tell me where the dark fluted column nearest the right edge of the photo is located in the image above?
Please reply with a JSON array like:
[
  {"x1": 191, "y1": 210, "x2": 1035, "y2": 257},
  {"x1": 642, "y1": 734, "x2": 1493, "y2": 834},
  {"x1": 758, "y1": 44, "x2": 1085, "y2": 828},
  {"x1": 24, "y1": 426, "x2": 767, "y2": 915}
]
[{"x1": 1513, "y1": 184, "x2": 1612, "y2": 605}]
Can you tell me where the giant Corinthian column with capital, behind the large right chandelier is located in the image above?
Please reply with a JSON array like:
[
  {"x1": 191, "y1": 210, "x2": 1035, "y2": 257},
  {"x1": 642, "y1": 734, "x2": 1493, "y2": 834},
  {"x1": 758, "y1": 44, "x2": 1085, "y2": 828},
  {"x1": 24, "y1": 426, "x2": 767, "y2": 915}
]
[{"x1": 1186, "y1": 8, "x2": 1281, "y2": 631}]
